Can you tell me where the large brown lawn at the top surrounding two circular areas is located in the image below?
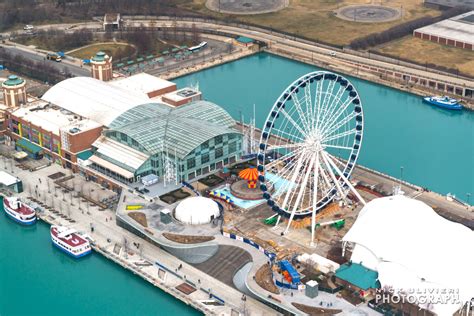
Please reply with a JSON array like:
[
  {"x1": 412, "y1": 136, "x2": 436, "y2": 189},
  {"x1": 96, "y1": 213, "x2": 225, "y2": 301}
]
[{"x1": 181, "y1": 0, "x2": 440, "y2": 45}]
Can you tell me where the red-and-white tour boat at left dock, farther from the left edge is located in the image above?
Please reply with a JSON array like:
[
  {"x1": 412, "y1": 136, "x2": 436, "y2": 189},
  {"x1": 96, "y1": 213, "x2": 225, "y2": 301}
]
[{"x1": 50, "y1": 225, "x2": 92, "y2": 258}]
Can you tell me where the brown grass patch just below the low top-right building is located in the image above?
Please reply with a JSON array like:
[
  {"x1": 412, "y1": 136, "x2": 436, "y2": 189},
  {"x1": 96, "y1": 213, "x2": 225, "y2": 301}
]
[{"x1": 376, "y1": 36, "x2": 474, "y2": 76}]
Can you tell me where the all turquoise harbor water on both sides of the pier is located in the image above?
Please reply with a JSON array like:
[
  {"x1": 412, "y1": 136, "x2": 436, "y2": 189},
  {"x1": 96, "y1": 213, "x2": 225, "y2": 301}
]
[{"x1": 0, "y1": 53, "x2": 474, "y2": 316}]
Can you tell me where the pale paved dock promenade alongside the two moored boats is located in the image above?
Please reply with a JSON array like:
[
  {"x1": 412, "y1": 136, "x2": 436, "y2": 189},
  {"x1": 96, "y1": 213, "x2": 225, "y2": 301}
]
[{"x1": 0, "y1": 158, "x2": 278, "y2": 315}]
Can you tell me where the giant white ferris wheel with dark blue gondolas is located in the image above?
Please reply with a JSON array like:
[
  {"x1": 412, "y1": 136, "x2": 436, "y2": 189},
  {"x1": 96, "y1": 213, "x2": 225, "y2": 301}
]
[{"x1": 257, "y1": 71, "x2": 365, "y2": 244}]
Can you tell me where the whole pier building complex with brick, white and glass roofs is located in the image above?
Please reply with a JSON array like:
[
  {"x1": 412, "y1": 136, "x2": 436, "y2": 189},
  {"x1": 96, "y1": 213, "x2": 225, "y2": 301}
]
[{"x1": 5, "y1": 59, "x2": 242, "y2": 189}]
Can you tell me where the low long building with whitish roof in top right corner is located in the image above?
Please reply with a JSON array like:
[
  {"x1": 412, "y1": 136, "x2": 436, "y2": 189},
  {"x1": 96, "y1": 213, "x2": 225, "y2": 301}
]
[{"x1": 413, "y1": 10, "x2": 474, "y2": 50}]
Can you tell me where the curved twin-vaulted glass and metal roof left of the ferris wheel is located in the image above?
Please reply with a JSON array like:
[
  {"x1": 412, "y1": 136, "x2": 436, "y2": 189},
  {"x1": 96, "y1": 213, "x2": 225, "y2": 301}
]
[{"x1": 107, "y1": 101, "x2": 240, "y2": 158}]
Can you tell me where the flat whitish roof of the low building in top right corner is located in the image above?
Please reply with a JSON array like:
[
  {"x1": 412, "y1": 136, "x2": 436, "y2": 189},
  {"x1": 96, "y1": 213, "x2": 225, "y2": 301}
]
[{"x1": 415, "y1": 11, "x2": 474, "y2": 44}]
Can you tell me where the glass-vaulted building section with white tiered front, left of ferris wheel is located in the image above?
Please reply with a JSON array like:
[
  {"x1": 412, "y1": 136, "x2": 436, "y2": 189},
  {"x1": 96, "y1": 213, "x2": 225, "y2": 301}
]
[{"x1": 89, "y1": 101, "x2": 242, "y2": 183}]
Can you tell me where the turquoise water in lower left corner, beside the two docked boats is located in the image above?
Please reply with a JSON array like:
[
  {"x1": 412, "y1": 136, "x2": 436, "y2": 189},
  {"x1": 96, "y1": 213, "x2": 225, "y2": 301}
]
[{"x1": 0, "y1": 200, "x2": 200, "y2": 316}]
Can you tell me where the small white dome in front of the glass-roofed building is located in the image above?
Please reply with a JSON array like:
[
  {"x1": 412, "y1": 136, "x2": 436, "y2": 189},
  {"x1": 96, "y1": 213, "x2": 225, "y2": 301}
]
[{"x1": 175, "y1": 196, "x2": 220, "y2": 225}]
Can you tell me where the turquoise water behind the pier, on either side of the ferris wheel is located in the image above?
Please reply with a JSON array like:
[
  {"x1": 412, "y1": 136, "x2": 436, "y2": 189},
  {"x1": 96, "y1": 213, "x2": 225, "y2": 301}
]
[{"x1": 175, "y1": 53, "x2": 474, "y2": 204}]
